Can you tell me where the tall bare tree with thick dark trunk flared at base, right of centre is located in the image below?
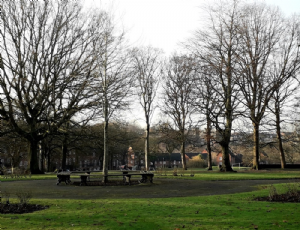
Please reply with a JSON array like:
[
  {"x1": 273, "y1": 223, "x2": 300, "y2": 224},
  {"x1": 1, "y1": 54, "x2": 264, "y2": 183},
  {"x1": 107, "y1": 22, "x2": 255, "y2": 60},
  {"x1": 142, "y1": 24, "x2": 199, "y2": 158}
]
[{"x1": 185, "y1": 0, "x2": 241, "y2": 171}]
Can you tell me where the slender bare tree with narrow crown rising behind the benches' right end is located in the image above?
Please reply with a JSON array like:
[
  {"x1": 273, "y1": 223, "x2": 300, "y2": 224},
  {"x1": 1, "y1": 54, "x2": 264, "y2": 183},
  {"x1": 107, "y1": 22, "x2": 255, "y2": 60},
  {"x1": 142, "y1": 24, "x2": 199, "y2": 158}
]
[{"x1": 133, "y1": 47, "x2": 162, "y2": 170}]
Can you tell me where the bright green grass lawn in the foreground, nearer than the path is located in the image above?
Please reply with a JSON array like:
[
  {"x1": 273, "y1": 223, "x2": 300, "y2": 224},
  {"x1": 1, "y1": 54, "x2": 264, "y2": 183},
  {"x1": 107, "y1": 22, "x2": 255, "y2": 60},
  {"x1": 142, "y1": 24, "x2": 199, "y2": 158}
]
[{"x1": 0, "y1": 184, "x2": 300, "y2": 230}]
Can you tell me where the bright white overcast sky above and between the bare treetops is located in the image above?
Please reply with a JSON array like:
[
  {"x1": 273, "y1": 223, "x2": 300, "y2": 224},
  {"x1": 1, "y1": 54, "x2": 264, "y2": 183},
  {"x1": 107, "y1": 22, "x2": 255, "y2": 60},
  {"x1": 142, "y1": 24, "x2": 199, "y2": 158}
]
[{"x1": 84, "y1": 0, "x2": 300, "y2": 54}]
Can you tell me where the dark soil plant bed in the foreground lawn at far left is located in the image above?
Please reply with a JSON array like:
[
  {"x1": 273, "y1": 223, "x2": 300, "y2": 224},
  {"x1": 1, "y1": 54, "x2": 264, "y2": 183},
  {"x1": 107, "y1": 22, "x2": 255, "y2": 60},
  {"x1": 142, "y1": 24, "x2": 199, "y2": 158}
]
[{"x1": 0, "y1": 203, "x2": 49, "y2": 214}]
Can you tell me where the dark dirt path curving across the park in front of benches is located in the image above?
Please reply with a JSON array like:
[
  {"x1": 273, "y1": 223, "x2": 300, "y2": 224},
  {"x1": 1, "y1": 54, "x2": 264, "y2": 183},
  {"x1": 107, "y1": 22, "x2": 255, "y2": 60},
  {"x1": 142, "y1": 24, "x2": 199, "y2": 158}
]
[{"x1": 0, "y1": 179, "x2": 300, "y2": 199}]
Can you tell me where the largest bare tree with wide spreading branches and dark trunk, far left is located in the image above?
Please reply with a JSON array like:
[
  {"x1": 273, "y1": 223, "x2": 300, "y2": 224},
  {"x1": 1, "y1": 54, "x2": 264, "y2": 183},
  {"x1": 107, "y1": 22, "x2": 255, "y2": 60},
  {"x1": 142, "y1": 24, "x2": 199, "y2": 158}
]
[{"x1": 0, "y1": 0, "x2": 103, "y2": 173}]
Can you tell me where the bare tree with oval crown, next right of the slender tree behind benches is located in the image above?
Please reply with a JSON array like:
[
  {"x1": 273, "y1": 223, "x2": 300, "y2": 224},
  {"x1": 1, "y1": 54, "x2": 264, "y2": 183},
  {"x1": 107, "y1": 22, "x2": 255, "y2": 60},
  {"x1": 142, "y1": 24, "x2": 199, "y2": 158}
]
[{"x1": 161, "y1": 55, "x2": 196, "y2": 169}]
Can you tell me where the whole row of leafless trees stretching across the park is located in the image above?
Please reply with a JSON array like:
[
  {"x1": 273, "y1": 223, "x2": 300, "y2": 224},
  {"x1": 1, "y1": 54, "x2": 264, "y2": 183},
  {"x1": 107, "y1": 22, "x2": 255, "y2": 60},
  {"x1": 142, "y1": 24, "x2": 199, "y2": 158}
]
[{"x1": 0, "y1": 0, "x2": 300, "y2": 175}]
